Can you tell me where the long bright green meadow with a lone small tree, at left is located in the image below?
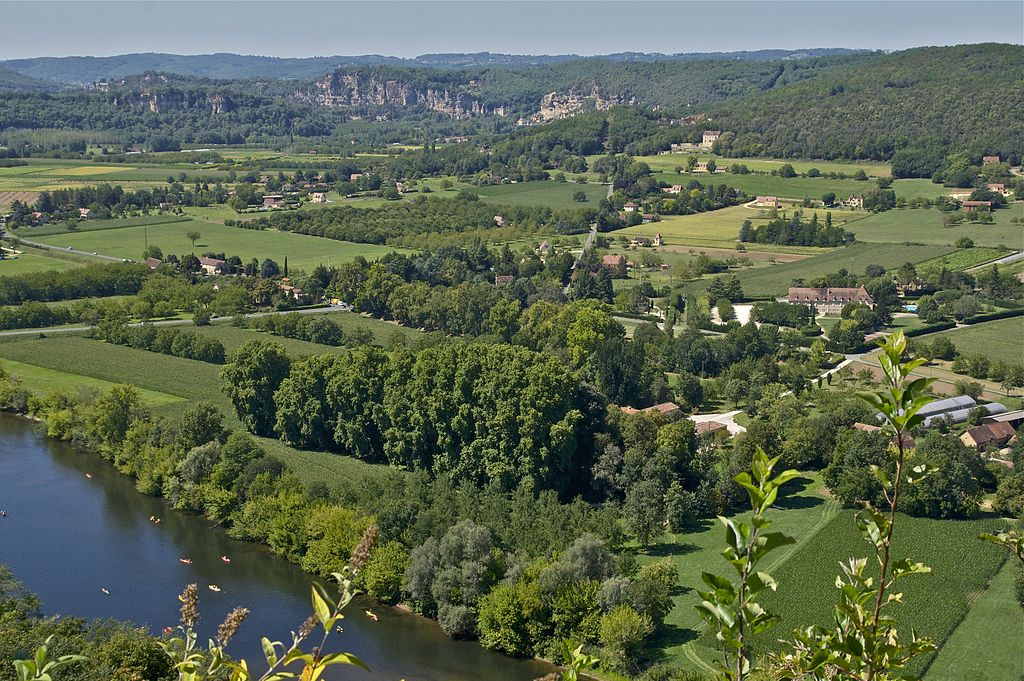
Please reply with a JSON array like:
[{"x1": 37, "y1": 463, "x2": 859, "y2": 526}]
[{"x1": 32, "y1": 220, "x2": 409, "y2": 272}]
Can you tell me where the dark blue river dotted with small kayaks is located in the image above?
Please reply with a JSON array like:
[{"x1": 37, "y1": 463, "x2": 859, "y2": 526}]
[{"x1": 0, "y1": 414, "x2": 551, "y2": 681}]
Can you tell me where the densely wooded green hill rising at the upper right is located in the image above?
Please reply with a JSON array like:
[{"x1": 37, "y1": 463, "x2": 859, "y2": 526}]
[{"x1": 711, "y1": 44, "x2": 1024, "y2": 163}]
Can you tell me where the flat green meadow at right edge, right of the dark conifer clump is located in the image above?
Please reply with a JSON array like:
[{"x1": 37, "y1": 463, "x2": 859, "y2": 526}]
[{"x1": 834, "y1": 202, "x2": 1024, "y2": 251}]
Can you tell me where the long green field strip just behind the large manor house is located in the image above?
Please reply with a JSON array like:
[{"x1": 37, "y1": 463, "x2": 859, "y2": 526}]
[{"x1": 686, "y1": 244, "x2": 953, "y2": 296}]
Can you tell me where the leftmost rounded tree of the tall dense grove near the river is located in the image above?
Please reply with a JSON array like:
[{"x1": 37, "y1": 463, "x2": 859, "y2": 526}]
[{"x1": 220, "y1": 339, "x2": 291, "y2": 436}]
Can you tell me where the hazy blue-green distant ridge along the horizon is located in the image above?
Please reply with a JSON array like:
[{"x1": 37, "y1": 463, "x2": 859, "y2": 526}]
[{"x1": 0, "y1": 47, "x2": 865, "y2": 85}]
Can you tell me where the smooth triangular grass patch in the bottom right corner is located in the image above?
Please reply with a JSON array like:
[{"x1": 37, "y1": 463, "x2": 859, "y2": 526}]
[{"x1": 925, "y1": 558, "x2": 1024, "y2": 681}]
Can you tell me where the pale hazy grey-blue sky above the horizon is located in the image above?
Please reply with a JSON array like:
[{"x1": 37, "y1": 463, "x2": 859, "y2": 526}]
[{"x1": 0, "y1": 0, "x2": 1024, "y2": 58}]
